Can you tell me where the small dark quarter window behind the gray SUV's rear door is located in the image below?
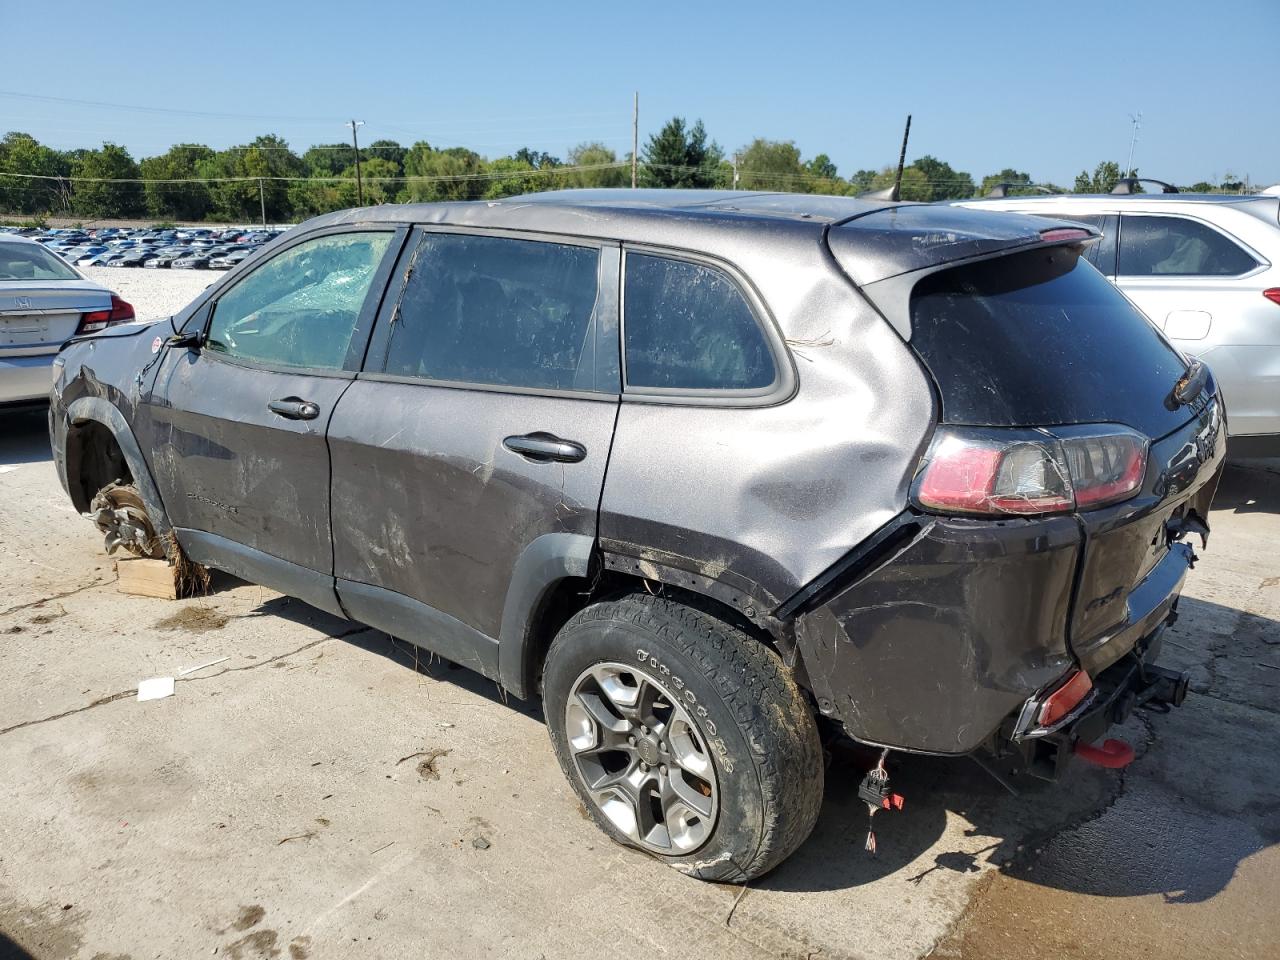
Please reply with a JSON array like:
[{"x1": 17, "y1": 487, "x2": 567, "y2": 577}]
[{"x1": 623, "y1": 253, "x2": 774, "y2": 390}]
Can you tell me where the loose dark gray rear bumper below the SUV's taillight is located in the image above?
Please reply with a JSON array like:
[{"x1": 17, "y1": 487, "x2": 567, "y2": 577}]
[{"x1": 796, "y1": 504, "x2": 1196, "y2": 755}]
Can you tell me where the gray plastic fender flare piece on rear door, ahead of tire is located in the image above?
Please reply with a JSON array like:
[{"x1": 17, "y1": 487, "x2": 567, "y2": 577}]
[{"x1": 498, "y1": 532, "x2": 595, "y2": 700}]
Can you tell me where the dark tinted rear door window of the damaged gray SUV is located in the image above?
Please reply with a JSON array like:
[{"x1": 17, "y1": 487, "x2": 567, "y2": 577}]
[{"x1": 387, "y1": 234, "x2": 600, "y2": 390}]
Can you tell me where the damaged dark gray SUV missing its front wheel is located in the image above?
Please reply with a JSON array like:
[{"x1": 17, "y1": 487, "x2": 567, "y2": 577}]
[{"x1": 50, "y1": 191, "x2": 1226, "y2": 882}]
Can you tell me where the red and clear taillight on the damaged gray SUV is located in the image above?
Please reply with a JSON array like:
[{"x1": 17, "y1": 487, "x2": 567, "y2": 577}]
[{"x1": 915, "y1": 425, "x2": 1147, "y2": 516}]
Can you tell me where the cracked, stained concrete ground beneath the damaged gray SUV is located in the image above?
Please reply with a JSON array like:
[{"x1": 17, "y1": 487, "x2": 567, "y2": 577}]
[{"x1": 0, "y1": 271, "x2": 1280, "y2": 960}]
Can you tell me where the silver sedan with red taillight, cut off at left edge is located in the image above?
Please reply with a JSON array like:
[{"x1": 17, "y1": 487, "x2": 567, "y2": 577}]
[{"x1": 0, "y1": 234, "x2": 133, "y2": 406}]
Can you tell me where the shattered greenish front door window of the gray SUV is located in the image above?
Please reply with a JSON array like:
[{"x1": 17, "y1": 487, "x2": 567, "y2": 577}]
[{"x1": 207, "y1": 232, "x2": 392, "y2": 370}]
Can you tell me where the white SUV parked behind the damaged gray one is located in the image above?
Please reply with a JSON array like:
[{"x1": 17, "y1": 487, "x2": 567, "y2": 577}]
[{"x1": 959, "y1": 193, "x2": 1280, "y2": 456}]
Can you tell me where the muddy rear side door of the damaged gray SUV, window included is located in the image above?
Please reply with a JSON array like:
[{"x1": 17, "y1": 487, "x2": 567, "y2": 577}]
[{"x1": 329, "y1": 229, "x2": 618, "y2": 676}]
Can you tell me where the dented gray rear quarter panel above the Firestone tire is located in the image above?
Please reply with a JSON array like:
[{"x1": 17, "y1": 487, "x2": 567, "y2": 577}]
[{"x1": 600, "y1": 229, "x2": 933, "y2": 617}]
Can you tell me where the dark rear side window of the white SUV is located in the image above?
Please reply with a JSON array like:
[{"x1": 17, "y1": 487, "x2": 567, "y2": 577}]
[{"x1": 1119, "y1": 214, "x2": 1258, "y2": 276}]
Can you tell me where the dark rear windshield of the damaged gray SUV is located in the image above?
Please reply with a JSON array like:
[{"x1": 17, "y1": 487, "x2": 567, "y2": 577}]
[{"x1": 911, "y1": 247, "x2": 1187, "y2": 438}]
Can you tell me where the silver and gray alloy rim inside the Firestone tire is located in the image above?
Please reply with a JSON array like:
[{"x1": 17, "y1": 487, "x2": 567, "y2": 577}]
[{"x1": 564, "y1": 663, "x2": 719, "y2": 856}]
